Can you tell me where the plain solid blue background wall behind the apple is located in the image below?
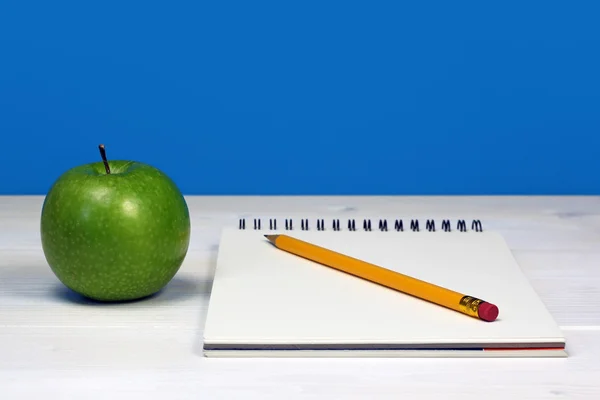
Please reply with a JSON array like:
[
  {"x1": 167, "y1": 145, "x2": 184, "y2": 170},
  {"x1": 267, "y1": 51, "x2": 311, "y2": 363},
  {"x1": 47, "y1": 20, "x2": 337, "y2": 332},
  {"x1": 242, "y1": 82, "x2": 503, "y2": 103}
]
[{"x1": 0, "y1": 0, "x2": 600, "y2": 194}]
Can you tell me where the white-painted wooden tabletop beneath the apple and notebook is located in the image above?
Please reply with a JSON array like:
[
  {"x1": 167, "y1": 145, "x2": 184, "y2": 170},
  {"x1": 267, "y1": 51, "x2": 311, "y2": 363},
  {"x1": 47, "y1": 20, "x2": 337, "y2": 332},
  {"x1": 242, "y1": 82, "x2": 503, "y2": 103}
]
[{"x1": 0, "y1": 197, "x2": 600, "y2": 400}]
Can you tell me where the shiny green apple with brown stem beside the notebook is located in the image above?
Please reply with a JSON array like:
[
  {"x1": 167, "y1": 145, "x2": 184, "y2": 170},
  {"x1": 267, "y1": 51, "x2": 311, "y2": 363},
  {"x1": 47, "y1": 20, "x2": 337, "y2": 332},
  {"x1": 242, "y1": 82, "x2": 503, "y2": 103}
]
[{"x1": 40, "y1": 145, "x2": 191, "y2": 301}]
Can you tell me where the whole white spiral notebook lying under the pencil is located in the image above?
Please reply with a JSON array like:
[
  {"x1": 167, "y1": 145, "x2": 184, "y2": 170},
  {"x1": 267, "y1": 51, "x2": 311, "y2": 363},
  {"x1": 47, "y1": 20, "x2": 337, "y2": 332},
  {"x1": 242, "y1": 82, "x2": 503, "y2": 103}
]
[{"x1": 204, "y1": 218, "x2": 567, "y2": 357}]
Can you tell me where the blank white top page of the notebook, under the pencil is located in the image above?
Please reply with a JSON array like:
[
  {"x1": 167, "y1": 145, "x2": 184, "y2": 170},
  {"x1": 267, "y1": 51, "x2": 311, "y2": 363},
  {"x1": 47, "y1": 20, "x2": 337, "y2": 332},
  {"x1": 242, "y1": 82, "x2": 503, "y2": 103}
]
[{"x1": 205, "y1": 229, "x2": 563, "y2": 345}]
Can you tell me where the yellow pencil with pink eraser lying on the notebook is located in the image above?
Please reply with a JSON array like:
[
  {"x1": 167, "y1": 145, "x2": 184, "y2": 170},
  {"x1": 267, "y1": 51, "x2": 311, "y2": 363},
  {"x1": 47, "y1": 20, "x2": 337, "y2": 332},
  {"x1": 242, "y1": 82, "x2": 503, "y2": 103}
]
[{"x1": 265, "y1": 235, "x2": 499, "y2": 322}]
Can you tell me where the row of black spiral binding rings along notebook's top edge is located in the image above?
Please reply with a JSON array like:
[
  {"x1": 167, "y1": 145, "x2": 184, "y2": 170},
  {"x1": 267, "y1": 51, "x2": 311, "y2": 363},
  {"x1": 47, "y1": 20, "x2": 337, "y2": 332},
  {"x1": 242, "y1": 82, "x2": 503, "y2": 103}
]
[{"x1": 238, "y1": 218, "x2": 483, "y2": 232}]
